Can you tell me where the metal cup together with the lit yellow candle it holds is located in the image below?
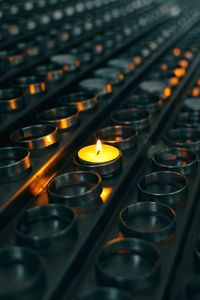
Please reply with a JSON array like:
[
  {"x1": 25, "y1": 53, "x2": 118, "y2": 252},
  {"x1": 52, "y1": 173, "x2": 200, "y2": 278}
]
[{"x1": 74, "y1": 140, "x2": 122, "y2": 176}]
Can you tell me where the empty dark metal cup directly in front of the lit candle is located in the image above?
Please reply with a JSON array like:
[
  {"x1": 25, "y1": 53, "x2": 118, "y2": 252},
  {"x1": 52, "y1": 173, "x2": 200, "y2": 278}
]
[{"x1": 47, "y1": 171, "x2": 102, "y2": 214}]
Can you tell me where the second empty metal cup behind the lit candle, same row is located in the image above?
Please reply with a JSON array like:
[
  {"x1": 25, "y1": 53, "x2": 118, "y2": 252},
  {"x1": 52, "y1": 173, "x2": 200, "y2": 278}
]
[{"x1": 112, "y1": 108, "x2": 152, "y2": 130}]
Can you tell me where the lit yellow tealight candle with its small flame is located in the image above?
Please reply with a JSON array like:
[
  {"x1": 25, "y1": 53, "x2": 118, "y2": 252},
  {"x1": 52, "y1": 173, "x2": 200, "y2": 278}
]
[{"x1": 78, "y1": 140, "x2": 120, "y2": 164}]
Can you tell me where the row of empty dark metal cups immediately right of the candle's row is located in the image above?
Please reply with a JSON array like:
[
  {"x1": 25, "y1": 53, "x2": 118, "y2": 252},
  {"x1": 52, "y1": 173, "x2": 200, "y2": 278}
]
[{"x1": 69, "y1": 59, "x2": 200, "y2": 300}]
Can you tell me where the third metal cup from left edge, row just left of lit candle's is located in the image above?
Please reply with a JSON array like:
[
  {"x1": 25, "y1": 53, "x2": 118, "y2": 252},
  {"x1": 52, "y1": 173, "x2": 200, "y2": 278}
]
[{"x1": 37, "y1": 106, "x2": 78, "y2": 130}]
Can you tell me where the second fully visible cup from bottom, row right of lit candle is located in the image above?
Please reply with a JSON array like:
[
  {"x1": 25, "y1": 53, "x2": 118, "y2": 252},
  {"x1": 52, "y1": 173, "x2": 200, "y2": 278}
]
[{"x1": 119, "y1": 202, "x2": 176, "y2": 242}]
